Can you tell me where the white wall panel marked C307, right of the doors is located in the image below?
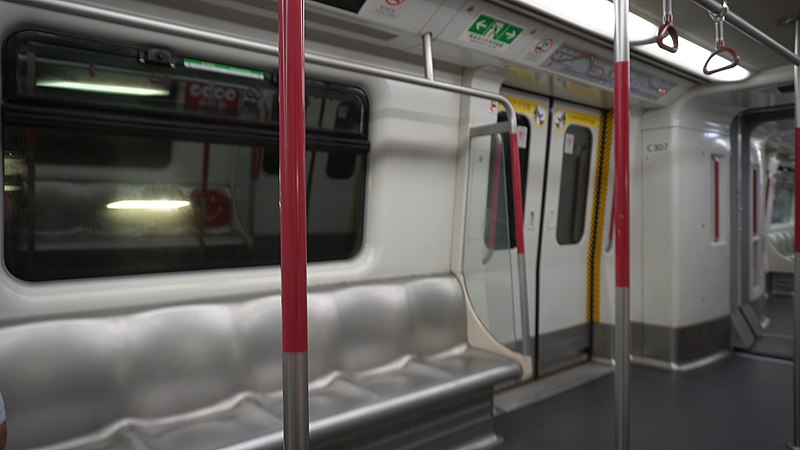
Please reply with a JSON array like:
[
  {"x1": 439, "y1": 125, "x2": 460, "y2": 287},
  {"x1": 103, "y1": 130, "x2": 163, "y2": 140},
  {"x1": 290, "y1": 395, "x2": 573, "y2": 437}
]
[{"x1": 643, "y1": 127, "x2": 730, "y2": 327}]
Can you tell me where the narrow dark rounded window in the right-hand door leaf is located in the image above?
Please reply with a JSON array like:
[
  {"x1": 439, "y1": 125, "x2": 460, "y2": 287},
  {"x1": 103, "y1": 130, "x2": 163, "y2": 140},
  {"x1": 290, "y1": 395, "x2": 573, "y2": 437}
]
[{"x1": 556, "y1": 125, "x2": 592, "y2": 245}]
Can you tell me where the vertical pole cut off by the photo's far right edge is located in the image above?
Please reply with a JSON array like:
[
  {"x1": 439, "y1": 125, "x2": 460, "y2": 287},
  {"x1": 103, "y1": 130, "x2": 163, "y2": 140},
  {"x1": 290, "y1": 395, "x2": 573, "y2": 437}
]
[{"x1": 792, "y1": 17, "x2": 800, "y2": 450}]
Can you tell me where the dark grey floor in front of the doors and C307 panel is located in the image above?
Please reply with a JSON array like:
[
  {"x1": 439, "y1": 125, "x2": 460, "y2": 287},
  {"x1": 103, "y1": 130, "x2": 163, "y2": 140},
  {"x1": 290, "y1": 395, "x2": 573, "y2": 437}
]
[{"x1": 495, "y1": 354, "x2": 792, "y2": 450}]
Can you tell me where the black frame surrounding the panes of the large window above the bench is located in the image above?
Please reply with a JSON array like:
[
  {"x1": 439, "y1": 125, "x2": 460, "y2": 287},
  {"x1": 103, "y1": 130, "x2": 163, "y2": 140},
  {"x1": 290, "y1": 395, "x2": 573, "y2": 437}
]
[{"x1": 1, "y1": 30, "x2": 370, "y2": 281}]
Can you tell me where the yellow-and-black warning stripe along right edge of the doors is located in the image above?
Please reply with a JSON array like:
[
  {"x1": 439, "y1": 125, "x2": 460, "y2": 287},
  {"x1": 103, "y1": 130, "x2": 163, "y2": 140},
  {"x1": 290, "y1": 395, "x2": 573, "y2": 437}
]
[{"x1": 586, "y1": 111, "x2": 614, "y2": 323}]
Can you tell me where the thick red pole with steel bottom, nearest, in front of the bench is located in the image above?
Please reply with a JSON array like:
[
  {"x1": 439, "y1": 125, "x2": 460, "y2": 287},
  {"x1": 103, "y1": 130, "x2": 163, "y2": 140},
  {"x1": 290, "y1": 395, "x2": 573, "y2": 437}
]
[{"x1": 278, "y1": 0, "x2": 308, "y2": 450}]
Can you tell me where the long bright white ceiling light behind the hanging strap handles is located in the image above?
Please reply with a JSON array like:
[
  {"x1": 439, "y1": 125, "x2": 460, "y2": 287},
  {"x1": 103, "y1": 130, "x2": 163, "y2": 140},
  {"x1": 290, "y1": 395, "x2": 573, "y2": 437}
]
[{"x1": 519, "y1": 0, "x2": 750, "y2": 81}]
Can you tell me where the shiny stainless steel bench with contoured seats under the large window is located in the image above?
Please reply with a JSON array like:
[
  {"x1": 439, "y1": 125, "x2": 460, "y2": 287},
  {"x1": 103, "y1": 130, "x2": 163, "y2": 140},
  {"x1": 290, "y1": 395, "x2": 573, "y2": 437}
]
[{"x1": 0, "y1": 276, "x2": 521, "y2": 450}]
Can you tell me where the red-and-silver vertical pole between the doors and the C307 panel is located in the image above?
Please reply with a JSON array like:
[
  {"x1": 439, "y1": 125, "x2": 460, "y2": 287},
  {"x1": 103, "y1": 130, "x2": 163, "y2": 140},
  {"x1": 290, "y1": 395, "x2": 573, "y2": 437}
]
[{"x1": 614, "y1": 0, "x2": 631, "y2": 450}]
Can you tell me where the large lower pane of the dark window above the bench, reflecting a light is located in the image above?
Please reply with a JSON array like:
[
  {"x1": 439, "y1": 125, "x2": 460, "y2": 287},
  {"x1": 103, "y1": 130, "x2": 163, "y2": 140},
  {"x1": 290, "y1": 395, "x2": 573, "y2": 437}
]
[{"x1": 5, "y1": 127, "x2": 365, "y2": 280}]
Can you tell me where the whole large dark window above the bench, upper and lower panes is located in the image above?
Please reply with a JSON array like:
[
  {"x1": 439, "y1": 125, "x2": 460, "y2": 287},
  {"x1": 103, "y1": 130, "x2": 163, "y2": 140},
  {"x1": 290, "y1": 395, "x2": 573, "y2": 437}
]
[{"x1": 3, "y1": 32, "x2": 369, "y2": 281}]
